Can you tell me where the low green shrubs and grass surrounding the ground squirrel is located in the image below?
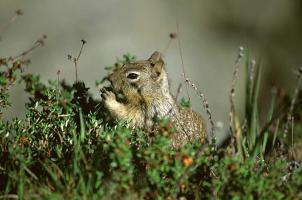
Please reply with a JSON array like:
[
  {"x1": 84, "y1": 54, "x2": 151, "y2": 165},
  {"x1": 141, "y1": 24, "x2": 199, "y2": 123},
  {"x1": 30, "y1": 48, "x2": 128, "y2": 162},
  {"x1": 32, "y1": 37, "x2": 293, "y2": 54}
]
[{"x1": 0, "y1": 45, "x2": 302, "y2": 199}]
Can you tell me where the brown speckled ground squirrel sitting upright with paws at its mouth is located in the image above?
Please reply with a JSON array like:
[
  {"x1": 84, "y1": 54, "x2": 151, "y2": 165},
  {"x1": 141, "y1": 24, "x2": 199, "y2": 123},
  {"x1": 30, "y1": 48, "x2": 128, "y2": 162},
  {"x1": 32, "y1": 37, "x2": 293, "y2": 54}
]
[{"x1": 102, "y1": 52, "x2": 206, "y2": 148}]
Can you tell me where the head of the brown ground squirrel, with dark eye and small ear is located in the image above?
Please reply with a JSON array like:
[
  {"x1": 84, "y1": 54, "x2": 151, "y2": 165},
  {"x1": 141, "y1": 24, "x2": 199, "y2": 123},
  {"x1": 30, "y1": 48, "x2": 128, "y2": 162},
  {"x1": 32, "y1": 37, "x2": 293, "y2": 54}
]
[{"x1": 109, "y1": 51, "x2": 169, "y2": 101}]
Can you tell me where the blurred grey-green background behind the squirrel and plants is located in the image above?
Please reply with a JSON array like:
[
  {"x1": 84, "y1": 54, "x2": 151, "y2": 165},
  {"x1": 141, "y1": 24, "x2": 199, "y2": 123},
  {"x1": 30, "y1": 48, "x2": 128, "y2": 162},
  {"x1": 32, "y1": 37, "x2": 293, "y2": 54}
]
[{"x1": 0, "y1": 0, "x2": 302, "y2": 138}]
